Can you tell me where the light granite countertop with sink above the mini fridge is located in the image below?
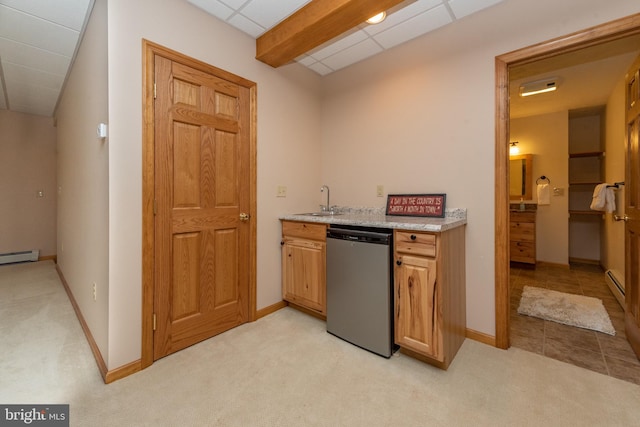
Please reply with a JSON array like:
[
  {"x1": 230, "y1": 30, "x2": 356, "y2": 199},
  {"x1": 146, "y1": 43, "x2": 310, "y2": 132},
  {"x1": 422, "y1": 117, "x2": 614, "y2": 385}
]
[{"x1": 279, "y1": 207, "x2": 467, "y2": 232}]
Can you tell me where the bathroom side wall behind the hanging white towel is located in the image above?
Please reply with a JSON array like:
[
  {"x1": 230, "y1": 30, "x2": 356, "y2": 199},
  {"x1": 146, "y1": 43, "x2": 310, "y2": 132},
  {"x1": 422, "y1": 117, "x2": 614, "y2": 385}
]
[{"x1": 601, "y1": 75, "x2": 631, "y2": 283}]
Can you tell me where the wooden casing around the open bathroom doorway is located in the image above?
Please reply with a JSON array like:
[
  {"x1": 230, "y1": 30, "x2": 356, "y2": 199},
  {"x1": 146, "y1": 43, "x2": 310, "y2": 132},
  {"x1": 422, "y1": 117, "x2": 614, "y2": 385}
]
[{"x1": 494, "y1": 13, "x2": 640, "y2": 349}]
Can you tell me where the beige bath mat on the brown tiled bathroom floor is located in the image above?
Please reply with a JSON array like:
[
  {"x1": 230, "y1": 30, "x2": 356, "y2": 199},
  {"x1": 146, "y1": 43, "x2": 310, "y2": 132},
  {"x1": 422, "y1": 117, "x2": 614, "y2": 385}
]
[{"x1": 518, "y1": 286, "x2": 616, "y2": 335}]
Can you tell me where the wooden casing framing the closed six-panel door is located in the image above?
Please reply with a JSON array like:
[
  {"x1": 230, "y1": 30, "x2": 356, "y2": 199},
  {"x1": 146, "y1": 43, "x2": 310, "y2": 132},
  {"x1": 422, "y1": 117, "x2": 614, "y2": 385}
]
[{"x1": 141, "y1": 40, "x2": 257, "y2": 369}]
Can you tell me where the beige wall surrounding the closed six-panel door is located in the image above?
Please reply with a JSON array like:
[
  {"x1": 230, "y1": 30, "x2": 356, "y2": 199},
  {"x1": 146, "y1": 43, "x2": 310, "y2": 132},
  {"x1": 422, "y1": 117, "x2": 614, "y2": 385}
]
[{"x1": 108, "y1": 0, "x2": 321, "y2": 369}]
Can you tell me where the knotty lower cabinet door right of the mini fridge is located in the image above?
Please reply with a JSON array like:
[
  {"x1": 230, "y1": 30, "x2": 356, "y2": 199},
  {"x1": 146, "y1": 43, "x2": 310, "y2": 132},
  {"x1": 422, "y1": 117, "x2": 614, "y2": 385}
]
[{"x1": 394, "y1": 254, "x2": 443, "y2": 361}]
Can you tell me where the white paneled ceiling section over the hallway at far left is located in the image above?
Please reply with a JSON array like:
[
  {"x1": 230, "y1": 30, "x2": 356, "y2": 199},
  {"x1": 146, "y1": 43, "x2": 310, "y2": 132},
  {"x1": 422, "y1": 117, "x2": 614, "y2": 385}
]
[{"x1": 0, "y1": 0, "x2": 93, "y2": 116}]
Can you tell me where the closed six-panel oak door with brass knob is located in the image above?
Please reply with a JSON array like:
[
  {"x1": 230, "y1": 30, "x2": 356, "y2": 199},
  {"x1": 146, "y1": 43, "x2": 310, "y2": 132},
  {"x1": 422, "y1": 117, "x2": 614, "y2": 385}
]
[{"x1": 153, "y1": 55, "x2": 251, "y2": 360}]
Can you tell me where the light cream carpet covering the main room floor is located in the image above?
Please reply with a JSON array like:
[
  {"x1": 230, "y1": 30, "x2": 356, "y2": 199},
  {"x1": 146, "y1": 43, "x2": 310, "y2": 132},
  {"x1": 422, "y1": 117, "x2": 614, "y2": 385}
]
[{"x1": 0, "y1": 262, "x2": 640, "y2": 427}]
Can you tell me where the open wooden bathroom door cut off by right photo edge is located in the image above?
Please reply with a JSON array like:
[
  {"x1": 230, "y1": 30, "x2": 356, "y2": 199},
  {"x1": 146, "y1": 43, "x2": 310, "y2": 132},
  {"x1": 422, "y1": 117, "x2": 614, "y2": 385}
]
[{"x1": 625, "y1": 57, "x2": 640, "y2": 357}]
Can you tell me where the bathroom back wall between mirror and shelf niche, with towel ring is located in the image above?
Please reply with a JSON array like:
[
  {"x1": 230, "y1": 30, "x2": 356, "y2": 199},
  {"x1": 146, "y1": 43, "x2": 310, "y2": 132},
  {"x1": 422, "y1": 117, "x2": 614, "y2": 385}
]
[{"x1": 510, "y1": 111, "x2": 569, "y2": 266}]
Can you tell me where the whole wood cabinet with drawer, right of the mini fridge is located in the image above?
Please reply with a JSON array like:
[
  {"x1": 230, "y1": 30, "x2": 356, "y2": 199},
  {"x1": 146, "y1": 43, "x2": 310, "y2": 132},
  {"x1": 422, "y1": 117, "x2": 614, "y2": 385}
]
[{"x1": 394, "y1": 226, "x2": 466, "y2": 369}]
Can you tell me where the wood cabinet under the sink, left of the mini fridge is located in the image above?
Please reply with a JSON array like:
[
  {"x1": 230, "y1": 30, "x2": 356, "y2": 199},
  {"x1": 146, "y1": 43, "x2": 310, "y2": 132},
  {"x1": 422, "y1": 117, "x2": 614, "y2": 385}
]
[{"x1": 282, "y1": 221, "x2": 327, "y2": 315}]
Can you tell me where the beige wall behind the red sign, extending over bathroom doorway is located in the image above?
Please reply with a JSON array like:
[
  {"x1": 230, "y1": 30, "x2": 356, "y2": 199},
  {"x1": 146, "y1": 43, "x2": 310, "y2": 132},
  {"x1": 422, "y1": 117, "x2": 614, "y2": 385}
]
[{"x1": 322, "y1": 0, "x2": 640, "y2": 335}]
